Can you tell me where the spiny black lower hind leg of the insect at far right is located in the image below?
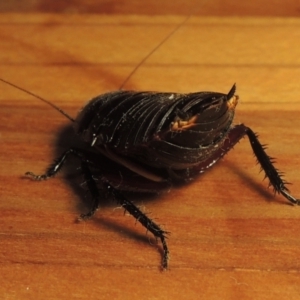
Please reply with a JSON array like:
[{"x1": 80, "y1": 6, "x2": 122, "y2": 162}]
[{"x1": 244, "y1": 124, "x2": 300, "y2": 205}]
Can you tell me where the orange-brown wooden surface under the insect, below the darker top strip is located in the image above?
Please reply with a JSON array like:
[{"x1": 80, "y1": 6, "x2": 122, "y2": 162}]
[{"x1": 0, "y1": 6, "x2": 300, "y2": 300}]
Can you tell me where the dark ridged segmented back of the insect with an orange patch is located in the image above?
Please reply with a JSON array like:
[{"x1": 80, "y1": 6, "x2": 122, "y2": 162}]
[{"x1": 75, "y1": 91, "x2": 234, "y2": 169}]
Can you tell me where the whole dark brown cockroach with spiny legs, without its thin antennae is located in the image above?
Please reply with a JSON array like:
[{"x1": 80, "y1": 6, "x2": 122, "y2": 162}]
[{"x1": 20, "y1": 85, "x2": 300, "y2": 269}]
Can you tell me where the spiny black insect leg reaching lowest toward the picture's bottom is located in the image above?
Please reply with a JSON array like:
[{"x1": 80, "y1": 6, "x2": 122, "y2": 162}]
[{"x1": 103, "y1": 181, "x2": 169, "y2": 269}]
